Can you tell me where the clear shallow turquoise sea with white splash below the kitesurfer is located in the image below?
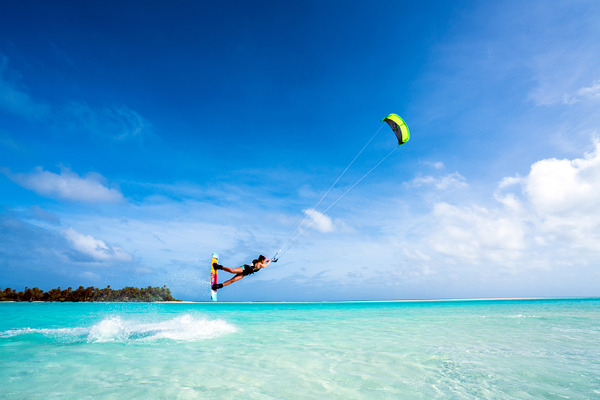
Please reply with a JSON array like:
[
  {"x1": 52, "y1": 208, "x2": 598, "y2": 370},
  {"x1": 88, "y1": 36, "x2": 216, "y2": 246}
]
[{"x1": 0, "y1": 299, "x2": 600, "y2": 399}]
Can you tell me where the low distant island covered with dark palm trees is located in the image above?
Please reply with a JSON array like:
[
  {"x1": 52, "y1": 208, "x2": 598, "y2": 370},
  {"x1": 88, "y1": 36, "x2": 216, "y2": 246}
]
[{"x1": 0, "y1": 285, "x2": 177, "y2": 302}]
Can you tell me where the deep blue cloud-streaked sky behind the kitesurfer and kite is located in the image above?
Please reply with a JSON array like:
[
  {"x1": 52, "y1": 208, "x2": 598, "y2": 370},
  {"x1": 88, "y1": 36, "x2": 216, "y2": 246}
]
[{"x1": 0, "y1": 1, "x2": 600, "y2": 301}]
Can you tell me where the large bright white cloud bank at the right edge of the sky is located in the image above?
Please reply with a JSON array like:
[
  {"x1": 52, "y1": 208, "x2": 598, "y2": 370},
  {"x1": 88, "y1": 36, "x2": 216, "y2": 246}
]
[{"x1": 426, "y1": 143, "x2": 600, "y2": 268}]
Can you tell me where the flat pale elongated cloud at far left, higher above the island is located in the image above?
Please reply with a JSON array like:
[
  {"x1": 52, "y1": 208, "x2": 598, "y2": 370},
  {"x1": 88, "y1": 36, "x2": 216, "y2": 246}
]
[{"x1": 2, "y1": 167, "x2": 123, "y2": 203}]
